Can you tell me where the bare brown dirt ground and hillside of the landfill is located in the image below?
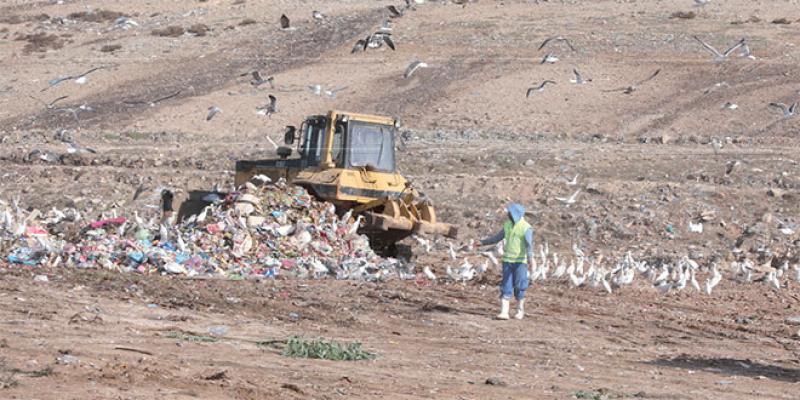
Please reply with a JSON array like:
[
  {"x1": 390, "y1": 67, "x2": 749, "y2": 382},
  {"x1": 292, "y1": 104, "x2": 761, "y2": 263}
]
[{"x1": 0, "y1": 0, "x2": 800, "y2": 399}]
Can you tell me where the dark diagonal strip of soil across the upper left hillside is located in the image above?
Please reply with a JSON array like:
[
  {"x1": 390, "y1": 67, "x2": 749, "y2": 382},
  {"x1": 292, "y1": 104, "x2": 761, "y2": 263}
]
[{"x1": 0, "y1": 9, "x2": 385, "y2": 129}]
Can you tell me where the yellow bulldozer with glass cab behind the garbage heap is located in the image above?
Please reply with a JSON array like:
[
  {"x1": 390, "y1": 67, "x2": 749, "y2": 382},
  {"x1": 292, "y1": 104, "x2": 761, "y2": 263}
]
[{"x1": 235, "y1": 111, "x2": 457, "y2": 252}]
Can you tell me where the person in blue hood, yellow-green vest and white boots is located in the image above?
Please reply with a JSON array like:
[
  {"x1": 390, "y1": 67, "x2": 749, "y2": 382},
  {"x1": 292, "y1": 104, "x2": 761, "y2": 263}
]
[{"x1": 480, "y1": 203, "x2": 533, "y2": 319}]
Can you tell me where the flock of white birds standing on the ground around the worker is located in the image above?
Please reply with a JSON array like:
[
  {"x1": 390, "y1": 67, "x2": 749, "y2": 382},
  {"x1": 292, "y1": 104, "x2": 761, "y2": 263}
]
[{"x1": 415, "y1": 236, "x2": 800, "y2": 295}]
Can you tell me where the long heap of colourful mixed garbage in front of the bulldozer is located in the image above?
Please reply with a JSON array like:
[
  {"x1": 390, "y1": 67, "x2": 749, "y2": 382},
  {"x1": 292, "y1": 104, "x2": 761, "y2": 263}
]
[{"x1": 0, "y1": 177, "x2": 416, "y2": 280}]
